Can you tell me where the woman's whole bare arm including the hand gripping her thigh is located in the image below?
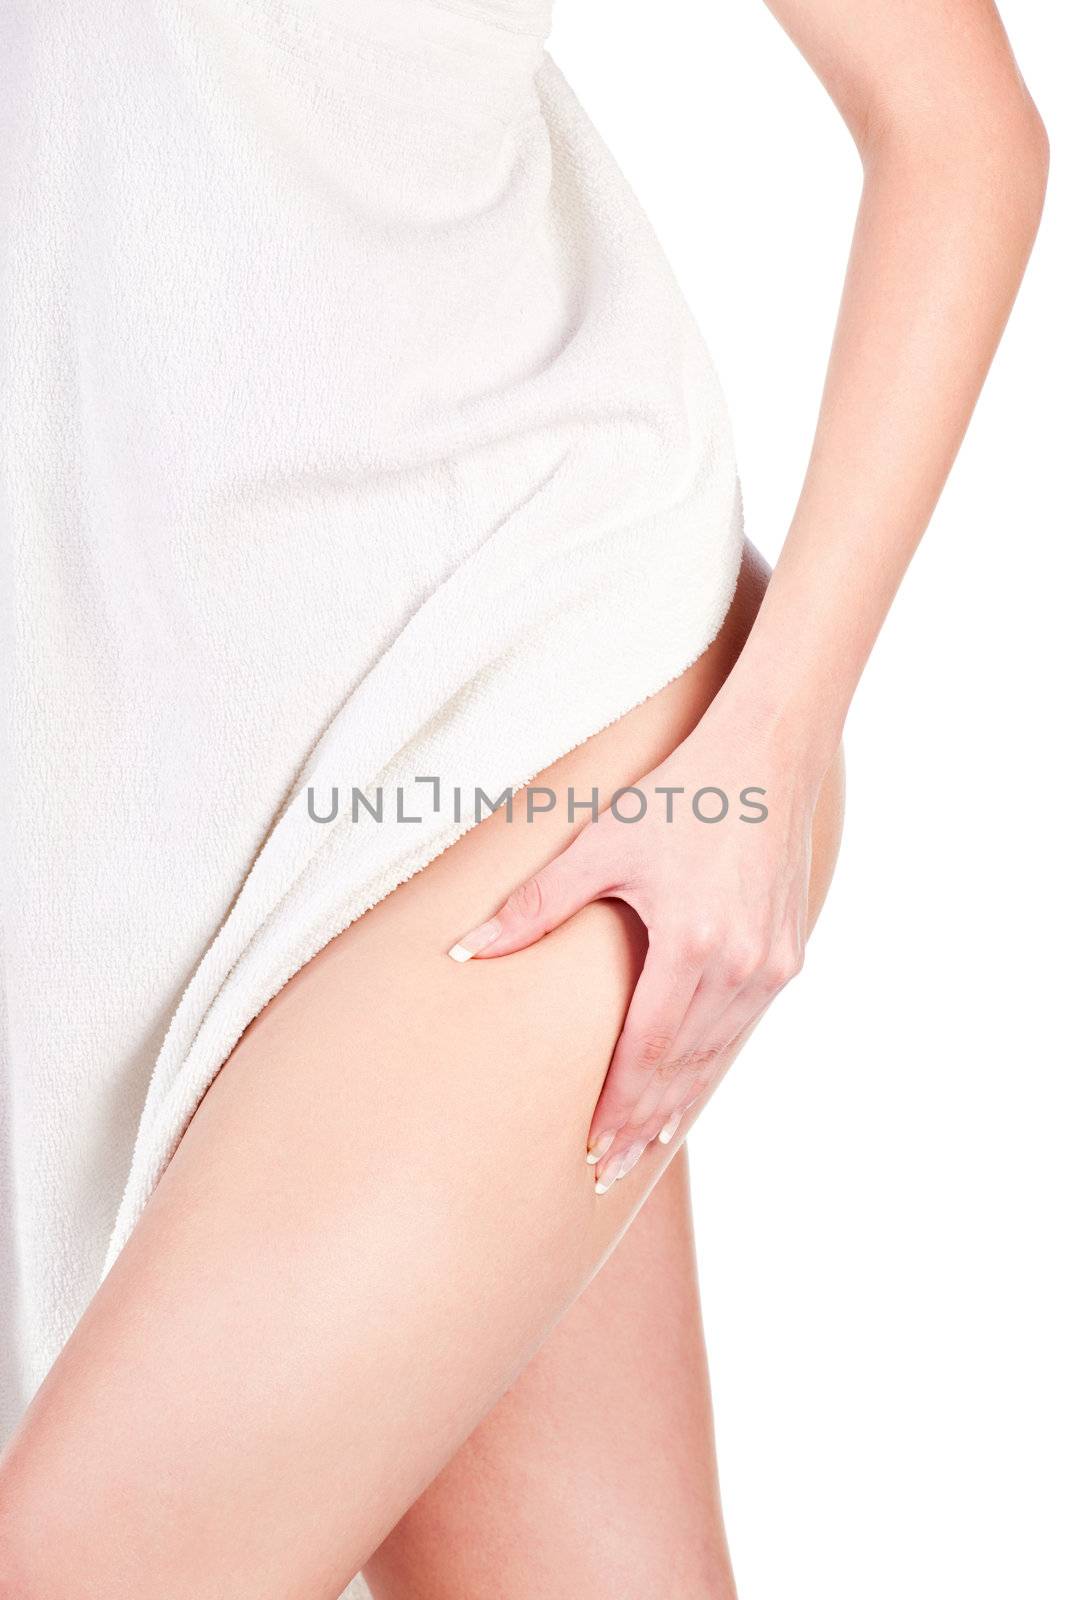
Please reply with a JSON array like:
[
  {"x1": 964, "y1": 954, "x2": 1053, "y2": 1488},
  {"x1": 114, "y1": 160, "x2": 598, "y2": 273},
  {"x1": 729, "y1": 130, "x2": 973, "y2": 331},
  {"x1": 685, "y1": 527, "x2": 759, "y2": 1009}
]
[{"x1": 451, "y1": 0, "x2": 1048, "y2": 1190}]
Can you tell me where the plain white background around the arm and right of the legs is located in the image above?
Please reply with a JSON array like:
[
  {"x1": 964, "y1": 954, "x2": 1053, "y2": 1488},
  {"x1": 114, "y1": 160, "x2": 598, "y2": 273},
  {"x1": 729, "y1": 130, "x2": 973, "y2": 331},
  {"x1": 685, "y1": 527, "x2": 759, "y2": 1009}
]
[{"x1": 552, "y1": 0, "x2": 1067, "y2": 1600}]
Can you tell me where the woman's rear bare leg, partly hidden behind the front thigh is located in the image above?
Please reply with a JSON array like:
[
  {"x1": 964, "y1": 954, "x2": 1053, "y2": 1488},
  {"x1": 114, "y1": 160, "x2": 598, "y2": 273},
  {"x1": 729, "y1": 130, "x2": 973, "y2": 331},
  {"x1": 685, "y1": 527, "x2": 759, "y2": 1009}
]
[{"x1": 366, "y1": 1146, "x2": 734, "y2": 1600}]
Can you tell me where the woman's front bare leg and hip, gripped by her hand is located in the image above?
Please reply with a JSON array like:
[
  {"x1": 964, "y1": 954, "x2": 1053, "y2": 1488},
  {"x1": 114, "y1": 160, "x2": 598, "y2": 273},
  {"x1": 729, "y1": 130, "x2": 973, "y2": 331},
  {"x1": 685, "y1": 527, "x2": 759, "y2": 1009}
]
[{"x1": 0, "y1": 544, "x2": 840, "y2": 1600}]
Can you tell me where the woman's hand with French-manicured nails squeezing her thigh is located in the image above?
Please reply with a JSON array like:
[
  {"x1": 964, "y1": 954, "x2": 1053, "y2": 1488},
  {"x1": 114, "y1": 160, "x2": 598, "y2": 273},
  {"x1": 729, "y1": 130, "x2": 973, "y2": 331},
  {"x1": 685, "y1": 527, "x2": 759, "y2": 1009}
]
[{"x1": 450, "y1": 696, "x2": 822, "y2": 1194}]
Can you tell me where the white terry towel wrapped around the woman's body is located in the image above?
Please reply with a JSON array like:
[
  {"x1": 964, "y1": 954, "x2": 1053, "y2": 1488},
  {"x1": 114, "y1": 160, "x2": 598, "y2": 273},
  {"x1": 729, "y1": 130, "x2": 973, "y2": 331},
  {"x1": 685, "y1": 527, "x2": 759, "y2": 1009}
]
[{"x1": 0, "y1": 0, "x2": 741, "y2": 1587}]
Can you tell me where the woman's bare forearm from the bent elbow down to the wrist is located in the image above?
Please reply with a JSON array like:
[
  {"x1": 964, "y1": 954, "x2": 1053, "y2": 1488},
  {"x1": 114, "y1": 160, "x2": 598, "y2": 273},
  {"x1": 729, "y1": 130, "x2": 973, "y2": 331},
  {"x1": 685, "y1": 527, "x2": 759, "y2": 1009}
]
[{"x1": 703, "y1": 67, "x2": 1046, "y2": 770}]
